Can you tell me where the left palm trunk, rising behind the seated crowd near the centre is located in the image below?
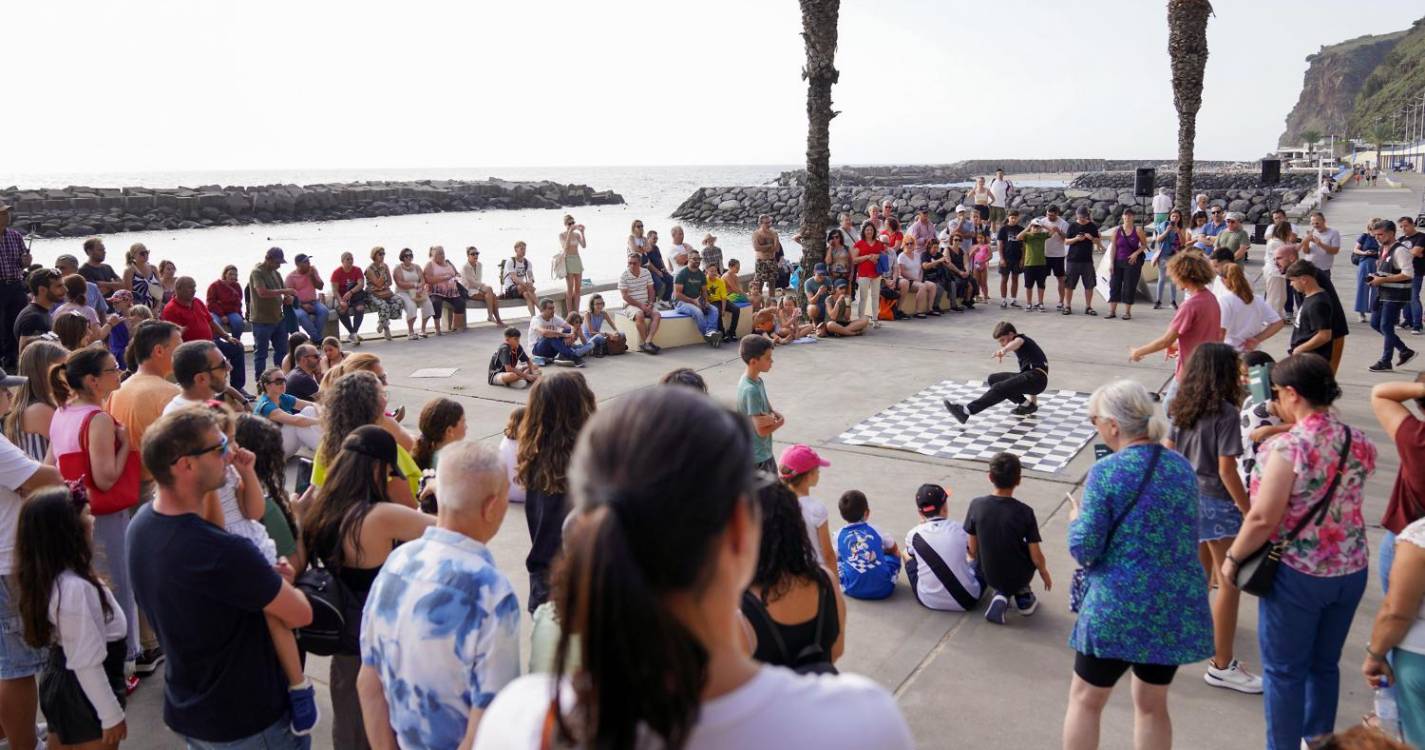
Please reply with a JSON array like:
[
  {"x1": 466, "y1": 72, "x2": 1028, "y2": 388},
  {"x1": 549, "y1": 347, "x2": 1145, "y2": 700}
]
[{"x1": 797, "y1": 0, "x2": 841, "y2": 288}]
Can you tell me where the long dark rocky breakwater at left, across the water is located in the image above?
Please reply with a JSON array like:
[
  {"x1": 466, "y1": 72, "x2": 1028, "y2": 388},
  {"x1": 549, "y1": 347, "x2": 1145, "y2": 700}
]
[{"x1": 0, "y1": 177, "x2": 624, "y2": 237}]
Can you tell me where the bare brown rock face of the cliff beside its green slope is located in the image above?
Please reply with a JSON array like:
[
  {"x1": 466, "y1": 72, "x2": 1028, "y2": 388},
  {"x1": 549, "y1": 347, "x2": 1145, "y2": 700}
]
[{"x1": 1277, "y1": 30, "x2": 1418, "y2": 147}]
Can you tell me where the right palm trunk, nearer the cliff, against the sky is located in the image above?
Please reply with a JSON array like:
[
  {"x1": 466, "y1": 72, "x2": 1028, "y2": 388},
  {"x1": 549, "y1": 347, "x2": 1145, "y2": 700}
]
[{"x1": 1167, "y1": 0, "x2": 1213, "y2": 210}]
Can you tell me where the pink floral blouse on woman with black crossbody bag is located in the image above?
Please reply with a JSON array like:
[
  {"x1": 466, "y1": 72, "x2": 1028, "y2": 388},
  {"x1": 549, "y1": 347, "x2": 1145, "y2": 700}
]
[{"x1": 1250, "y1": 412, "x2": 1375, "y2": 577}]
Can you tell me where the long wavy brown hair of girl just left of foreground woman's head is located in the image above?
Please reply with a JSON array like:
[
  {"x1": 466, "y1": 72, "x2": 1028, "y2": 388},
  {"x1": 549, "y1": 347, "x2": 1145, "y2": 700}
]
[{"x1": 514, "y1": 371, "x2": 594, "y2": 495}]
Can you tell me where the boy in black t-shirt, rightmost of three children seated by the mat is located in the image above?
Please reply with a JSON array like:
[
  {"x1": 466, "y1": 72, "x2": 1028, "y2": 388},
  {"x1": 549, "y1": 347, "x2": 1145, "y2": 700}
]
[{"x1": 965, "y1": 453, "x2": 1053, "y2": 625}]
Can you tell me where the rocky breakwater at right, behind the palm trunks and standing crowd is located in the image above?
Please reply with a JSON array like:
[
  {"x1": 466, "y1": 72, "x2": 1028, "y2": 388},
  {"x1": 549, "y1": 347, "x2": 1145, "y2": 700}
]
[{"x1": 673, "y1": 185, "x2": 1301, "y2": 227}]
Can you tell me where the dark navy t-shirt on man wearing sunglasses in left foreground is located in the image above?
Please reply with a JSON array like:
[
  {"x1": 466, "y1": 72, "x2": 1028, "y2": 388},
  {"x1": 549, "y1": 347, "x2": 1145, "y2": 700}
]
[{"x1": 128, "y1": 505, "x2": 288, "y2": 743}]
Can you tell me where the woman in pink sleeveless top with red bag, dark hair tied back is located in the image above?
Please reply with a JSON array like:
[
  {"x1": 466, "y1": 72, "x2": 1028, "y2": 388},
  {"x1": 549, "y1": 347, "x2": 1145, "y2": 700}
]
[{"x1": 50, "y1": 346, "x2": 138, "y2": 673}]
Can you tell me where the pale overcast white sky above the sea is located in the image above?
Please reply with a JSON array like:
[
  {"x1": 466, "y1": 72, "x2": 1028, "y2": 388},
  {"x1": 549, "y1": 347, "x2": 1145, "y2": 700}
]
[{"x1": 11, "y1": 0, "x2": 1422, "y2": 173}]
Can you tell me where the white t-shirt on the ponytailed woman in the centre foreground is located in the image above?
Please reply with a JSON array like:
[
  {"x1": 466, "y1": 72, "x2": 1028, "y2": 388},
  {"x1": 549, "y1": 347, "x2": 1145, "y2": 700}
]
[{"x1": 475, "y1": 666, "x2": 913, "y2": 750}]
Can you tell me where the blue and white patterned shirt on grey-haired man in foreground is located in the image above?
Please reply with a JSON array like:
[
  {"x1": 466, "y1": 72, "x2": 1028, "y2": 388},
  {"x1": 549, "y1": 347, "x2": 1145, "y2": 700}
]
[{"x1": 361, "y1": 528, "x2": 520, "y2": 749}]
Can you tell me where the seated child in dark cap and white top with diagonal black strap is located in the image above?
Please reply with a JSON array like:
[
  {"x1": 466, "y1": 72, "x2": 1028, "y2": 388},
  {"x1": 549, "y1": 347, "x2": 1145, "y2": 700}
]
[{"x1": 905, "y1": 485, "x2": 985, "y2": 612}]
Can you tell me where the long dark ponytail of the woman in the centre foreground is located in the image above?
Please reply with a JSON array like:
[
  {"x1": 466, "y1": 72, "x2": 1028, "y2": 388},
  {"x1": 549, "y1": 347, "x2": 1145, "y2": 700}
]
[{"x1": 551, "y1": 506, "x2": 708, "y2": 750}]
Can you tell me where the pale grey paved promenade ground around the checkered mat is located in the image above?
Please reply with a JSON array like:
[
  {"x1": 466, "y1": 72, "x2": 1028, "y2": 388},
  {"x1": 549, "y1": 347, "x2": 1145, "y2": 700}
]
[{"x1": 105, "y1": 177, "x2": 1425, "y2": 749}]
